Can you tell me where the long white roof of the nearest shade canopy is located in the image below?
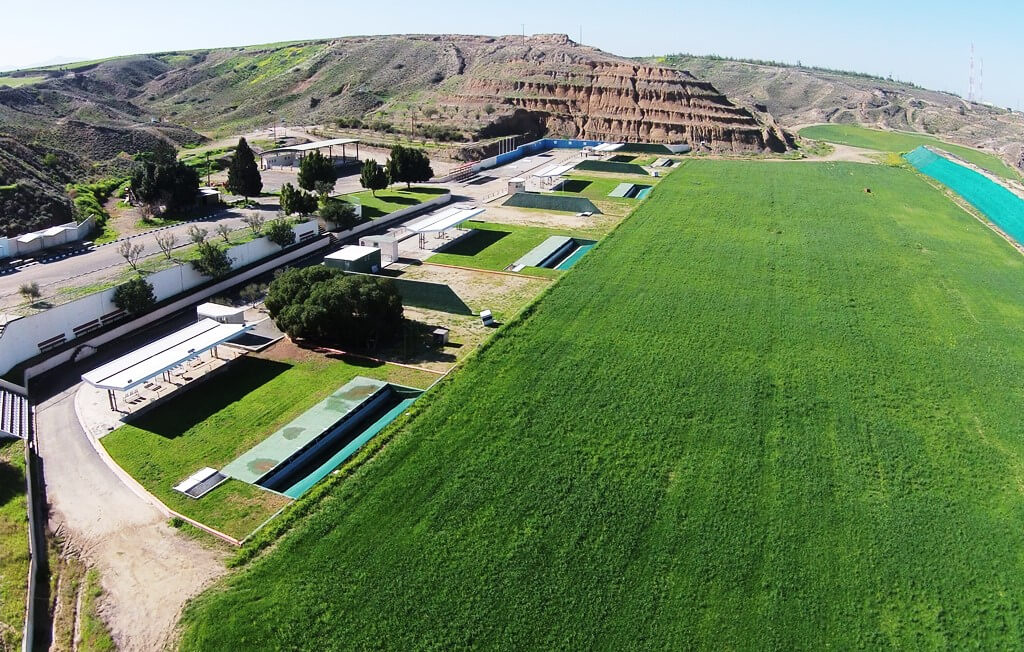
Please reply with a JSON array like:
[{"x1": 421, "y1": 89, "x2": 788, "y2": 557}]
[{"x1": 82, "y1": 319, "x2": 252, "y2": 392}]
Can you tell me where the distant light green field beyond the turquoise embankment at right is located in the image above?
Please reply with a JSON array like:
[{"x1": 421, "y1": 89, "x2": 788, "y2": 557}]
[{"x1": 800, "y1": 125, "x2": 1021, "y2": 179}]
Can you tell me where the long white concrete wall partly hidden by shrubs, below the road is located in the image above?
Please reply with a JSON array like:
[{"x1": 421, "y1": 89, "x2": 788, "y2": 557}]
[{"x1": 0, "y1": 221, "x2": 317, "y2": 373}]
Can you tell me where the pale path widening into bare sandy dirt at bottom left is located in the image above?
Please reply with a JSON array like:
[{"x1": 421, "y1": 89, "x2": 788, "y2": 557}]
[{"x1": 37, "y1": 386, "x2": 226, "y2": 650}]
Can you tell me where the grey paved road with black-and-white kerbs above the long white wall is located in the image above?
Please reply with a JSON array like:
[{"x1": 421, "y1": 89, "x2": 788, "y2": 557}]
[{"x1": 0, "y1": 198, "x2": 279, "y2": 306}]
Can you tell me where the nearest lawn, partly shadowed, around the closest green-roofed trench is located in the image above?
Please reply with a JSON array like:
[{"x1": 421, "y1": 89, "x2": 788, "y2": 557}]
[{"x1": 100, "y1": 357, "x2": 434, "y2": 538}]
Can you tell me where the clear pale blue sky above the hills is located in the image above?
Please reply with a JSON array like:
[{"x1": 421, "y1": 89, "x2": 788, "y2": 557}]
[{"x1": 0, "y1": 0, "x2": 1024, "y2": 108}]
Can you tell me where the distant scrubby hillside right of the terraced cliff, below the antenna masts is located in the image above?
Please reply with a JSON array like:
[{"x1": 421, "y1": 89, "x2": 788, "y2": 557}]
[{"x1": 644, "y1": 55, "x2": 1024, "y2": 170}]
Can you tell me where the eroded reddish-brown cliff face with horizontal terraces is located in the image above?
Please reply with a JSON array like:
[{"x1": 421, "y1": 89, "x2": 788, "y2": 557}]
[{"x1": 444, "y1": 37, "x2": 791, "y2": 151}]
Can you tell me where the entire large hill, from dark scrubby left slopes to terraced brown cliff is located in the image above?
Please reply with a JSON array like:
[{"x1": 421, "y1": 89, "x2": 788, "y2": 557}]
[{"x1": 0, "y1": 35, "x2": 792, "y2": 233}]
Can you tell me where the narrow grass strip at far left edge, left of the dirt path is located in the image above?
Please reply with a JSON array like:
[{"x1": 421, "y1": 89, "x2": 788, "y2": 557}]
[{"x1": 0, "y1": 438, "x2": 29, "y2": 650}]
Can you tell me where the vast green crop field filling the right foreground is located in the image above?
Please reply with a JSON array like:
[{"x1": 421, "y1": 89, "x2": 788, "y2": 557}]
[{"x1": 183, "y1": 161, "x2": 1024, "y2": 650}]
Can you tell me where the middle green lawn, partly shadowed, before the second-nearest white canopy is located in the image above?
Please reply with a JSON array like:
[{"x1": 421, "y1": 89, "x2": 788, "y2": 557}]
[{"x1": 427, "y1": 220, "x2": 574, "y2": 271}]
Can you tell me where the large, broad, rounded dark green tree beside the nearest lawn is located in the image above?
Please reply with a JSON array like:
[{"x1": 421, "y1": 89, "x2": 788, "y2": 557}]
[{"x1": 264, "y1": 267, "x2": 402, "y2": 347}]
